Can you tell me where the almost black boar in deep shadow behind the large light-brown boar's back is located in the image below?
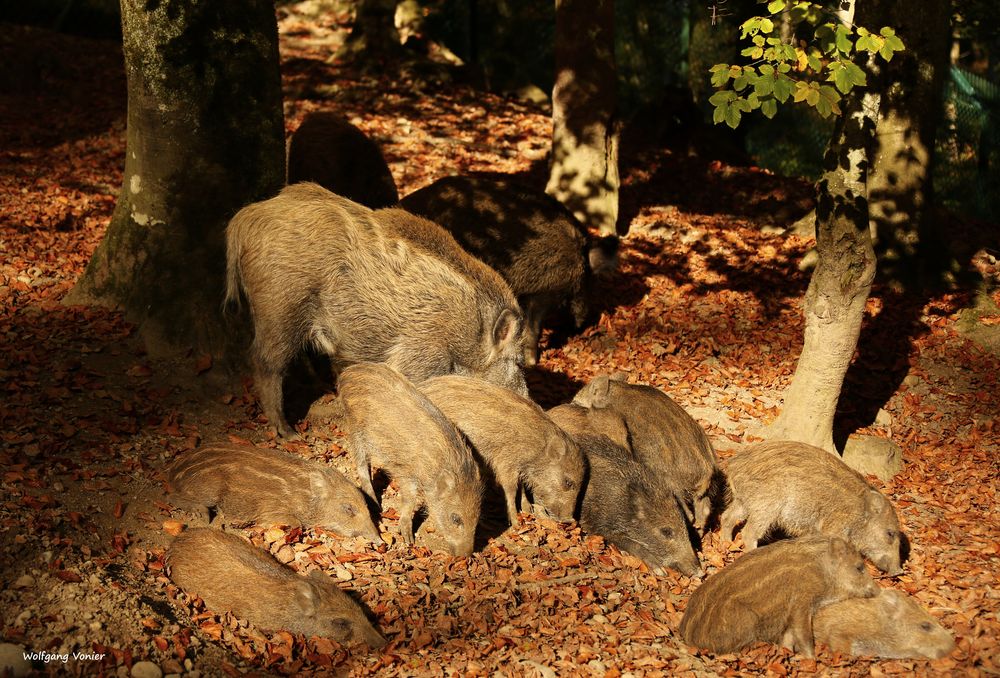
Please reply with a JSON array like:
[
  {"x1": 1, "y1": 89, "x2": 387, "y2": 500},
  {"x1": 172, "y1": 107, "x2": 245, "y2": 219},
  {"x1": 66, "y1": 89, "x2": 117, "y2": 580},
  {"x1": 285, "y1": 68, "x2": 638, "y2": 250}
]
[{"x1": 288, "y1": 111, "x2": 399, "y2": 209}]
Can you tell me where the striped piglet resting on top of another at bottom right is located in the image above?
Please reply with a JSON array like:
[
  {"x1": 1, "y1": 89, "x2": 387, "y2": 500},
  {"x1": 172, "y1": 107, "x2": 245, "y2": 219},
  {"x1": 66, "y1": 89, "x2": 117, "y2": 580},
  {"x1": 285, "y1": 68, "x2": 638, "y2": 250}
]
[{"x1": 680, "y1": 535, "x2": 879, "y2": 657}]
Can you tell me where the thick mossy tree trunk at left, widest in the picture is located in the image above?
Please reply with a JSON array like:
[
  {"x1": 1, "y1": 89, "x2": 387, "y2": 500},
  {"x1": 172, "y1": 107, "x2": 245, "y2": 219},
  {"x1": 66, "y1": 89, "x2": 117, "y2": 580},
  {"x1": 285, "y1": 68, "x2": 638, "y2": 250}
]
[{"x1": 65, "y1": 0, "x2": 284, "y2": 353}]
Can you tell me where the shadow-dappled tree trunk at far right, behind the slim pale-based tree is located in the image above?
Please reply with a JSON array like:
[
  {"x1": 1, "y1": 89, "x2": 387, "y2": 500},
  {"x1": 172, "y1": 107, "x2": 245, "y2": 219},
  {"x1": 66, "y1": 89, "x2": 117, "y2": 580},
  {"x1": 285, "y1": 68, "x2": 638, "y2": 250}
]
[{"x1": 868, "y1": 0, "x2": 951, "y2": 286}]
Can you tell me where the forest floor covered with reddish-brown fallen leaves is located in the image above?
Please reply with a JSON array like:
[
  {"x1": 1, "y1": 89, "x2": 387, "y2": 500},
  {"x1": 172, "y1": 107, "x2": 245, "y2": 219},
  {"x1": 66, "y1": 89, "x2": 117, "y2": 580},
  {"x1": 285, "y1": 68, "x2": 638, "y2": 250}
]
[{"x1": 0, "y1": 9, "x2": 1000, "y2": 676}]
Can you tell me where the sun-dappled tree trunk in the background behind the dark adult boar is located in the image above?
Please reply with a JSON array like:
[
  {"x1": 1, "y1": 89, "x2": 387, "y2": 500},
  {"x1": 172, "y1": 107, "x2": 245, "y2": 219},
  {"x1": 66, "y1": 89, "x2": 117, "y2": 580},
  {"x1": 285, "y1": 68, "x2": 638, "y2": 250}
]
[{"x1": 545, "y1": 0, "x2": 619, "y2": 235}]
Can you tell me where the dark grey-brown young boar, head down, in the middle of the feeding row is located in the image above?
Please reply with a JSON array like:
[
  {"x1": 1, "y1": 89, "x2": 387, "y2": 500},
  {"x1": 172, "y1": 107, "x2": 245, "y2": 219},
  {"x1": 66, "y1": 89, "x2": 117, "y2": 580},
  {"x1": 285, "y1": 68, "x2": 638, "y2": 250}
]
[{"x1": 573, "y1": 432, "x2": 702, "y2": 576}]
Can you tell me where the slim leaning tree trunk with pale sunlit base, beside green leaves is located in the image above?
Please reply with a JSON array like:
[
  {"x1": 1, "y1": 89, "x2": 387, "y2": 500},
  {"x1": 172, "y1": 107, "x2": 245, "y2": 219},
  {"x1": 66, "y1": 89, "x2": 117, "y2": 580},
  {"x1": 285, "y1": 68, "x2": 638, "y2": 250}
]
[{"x1": 767, "y1": 49, "x2": 880, "y2": 453}]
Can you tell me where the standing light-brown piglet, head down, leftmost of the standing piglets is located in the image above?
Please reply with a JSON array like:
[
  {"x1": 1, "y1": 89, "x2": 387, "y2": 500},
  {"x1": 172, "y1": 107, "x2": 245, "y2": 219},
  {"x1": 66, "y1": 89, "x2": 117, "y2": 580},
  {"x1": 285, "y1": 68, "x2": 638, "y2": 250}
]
[{"x1": 337, "y1": 363, "x2": 483, "y2": 556}]
